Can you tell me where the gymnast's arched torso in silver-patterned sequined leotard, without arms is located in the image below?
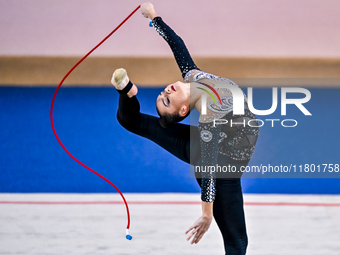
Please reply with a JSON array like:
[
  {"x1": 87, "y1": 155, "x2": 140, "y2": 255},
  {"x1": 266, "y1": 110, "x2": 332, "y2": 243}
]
[{"x1": 184, "y1": 70, "x2": 259, "y2": 161}]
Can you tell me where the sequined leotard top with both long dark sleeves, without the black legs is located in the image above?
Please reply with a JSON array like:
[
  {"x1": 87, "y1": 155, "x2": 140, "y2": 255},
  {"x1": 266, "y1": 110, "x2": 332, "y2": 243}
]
[{"x1": 153, "y1": 17, "x2": 259, "y2": 202}]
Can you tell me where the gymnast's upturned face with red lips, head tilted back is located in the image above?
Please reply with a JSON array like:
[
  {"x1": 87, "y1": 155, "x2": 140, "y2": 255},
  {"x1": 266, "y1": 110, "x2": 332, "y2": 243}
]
[{"x1": 156, "y1": 81, "x2": 190, "y2": 117}]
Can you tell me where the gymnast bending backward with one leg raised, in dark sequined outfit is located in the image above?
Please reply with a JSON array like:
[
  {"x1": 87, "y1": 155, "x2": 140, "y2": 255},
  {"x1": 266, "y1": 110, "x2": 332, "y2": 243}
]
[{"x1": 111, "y1": 3, "x2": 259, "y2": 255}]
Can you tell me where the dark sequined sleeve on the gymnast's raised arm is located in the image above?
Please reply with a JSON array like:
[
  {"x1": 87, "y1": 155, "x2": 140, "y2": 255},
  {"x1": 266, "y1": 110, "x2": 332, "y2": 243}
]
[{"x1": 152, "y1": 17, "x2": 199, "y2": 78}]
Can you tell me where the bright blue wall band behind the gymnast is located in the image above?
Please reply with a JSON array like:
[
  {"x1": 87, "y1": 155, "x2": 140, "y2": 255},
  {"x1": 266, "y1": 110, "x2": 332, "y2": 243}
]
[{"x1": 0, "y1": 87, "x2": 340, "y2": 194}]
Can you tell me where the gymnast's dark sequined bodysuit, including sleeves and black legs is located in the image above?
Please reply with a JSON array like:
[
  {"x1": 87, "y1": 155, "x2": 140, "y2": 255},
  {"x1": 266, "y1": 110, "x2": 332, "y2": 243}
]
[{"x1": 117, "y1": 17, "x2": 258, "y2": 255}]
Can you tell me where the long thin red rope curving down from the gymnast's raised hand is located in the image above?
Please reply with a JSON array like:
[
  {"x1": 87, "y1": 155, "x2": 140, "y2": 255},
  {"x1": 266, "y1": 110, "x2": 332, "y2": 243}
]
[{"x1": 50, "y1": 5, "x2": 140, "y2": 229}]
